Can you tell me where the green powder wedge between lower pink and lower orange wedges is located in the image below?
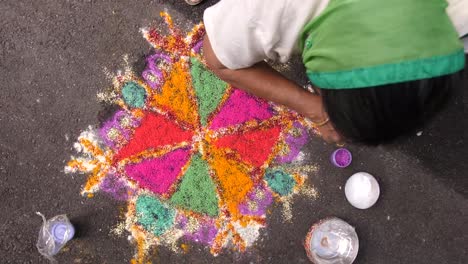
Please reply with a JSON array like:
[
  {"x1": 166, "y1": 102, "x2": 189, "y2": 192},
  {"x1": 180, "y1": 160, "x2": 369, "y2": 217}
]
[{"x1": 171, "y1": 154, "x2": 218, "y2": 216}]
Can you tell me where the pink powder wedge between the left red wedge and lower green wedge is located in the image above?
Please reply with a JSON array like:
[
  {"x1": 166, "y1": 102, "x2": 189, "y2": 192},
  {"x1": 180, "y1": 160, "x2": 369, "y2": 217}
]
[{"x1": 125, "y1": 148, "x2": 190, "y2": 194}]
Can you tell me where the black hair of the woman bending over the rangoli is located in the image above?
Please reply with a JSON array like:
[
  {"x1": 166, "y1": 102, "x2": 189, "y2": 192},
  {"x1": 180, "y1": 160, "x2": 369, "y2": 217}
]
[{"x1": 320, "y1": 73, "x2": 460, "y2": 145}]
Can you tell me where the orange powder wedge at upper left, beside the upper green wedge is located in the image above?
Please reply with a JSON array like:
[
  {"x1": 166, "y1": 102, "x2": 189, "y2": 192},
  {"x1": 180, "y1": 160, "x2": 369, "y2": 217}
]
[{"x1": 151, "y1": 60, "x2": 198, "y2": 127}]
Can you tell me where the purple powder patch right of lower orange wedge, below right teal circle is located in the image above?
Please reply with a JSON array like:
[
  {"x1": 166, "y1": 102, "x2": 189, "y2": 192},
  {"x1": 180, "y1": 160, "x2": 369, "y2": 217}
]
[{"x1": 239, "y1": 186, "x2": 273, "y2": 216}]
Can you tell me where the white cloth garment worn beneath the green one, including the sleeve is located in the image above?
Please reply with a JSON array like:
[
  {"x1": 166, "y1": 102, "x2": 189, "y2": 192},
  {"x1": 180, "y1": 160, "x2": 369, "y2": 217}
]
[{"x1": 203, "y1": 0, "x2": 468, "y2": 69}]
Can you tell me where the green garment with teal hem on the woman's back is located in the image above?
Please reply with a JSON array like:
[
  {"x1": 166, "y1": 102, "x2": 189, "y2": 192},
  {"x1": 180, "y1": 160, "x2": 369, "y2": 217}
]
[{"x1": 300, "y1": 0, "x2": 465, "y2": 89}]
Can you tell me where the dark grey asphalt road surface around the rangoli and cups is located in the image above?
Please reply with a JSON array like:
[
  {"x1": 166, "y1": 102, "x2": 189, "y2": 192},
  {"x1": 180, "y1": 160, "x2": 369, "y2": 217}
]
[{"x1": 0, "y1": 0, "x2": 468, "y2": 264}]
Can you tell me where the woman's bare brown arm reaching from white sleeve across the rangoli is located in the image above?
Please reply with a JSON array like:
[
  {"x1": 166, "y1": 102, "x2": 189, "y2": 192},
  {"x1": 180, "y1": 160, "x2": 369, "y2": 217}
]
[{"x1": 203, "y1": 35, "x2": 340, "y2": 142}]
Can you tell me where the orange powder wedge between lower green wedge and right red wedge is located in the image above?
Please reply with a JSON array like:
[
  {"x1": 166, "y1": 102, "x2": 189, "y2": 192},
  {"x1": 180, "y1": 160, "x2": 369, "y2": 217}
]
[{"x1": 209, "y1": 148, "x2": 254, "y2": 219}]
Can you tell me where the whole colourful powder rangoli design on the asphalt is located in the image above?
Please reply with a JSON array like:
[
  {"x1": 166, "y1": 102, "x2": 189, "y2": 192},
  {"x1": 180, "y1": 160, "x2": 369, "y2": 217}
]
[{"x1": 66, "y1": 13, "x2": 318, "y2": 263}]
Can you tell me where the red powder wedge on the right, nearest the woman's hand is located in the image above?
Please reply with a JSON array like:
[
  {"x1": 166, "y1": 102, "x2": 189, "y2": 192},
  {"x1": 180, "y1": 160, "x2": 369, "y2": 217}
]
[{"x1": 214, "y1": 126, "x2": 281, "y2": 167}]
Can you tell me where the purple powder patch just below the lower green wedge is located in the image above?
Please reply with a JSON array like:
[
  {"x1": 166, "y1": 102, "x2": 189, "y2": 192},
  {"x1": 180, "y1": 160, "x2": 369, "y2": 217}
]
[{"x1": 177, "y1": 214, "x2": 218, "y2": 246}]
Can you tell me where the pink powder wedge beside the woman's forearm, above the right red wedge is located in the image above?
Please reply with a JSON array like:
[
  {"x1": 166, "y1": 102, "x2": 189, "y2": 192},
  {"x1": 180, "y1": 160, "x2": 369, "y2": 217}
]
[{"x1": 210, "y1": 89, "x2": 272, "y2": 129}]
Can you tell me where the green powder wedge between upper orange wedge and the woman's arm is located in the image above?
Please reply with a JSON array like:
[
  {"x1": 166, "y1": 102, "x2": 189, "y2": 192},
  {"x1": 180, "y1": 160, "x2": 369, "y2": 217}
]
[{"x1": 190, "y1": 58, "x2": 227, "y2": 126}]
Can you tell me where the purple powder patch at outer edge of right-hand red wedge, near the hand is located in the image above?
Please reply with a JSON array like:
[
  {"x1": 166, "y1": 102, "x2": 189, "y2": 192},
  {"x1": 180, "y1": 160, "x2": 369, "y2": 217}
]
[{"x1": 276, "y1": 122, "x2": 309, "y2": 164}]
